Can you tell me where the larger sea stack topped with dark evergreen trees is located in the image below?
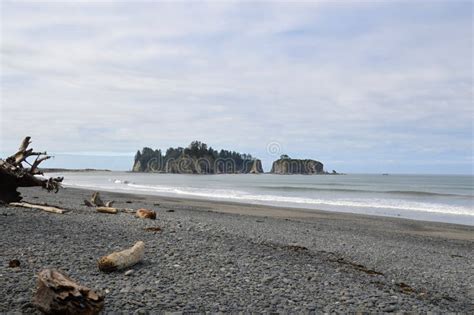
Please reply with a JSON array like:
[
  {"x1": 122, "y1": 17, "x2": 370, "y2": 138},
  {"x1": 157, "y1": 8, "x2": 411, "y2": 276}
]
[{"x1": 132, "y1": 141, "x2": 263, "y2": 174}]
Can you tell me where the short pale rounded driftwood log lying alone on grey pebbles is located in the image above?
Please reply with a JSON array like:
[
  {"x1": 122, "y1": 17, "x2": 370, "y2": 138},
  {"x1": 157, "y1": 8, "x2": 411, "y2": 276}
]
[{"x1": 97, "y1": 241, "x2": 145, "y2": 272}]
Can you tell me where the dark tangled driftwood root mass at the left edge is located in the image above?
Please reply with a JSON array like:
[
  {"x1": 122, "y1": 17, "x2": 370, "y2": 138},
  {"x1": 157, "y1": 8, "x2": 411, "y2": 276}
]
[{"x1": 0, "y1": 137, "x2": 63, "y2": 203}]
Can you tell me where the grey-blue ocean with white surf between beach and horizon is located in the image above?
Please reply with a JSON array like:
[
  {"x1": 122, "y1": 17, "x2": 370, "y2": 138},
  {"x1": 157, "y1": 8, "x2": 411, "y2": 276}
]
[{"x1": 47, "y1": 172, "x2": 474, "y2": 225}]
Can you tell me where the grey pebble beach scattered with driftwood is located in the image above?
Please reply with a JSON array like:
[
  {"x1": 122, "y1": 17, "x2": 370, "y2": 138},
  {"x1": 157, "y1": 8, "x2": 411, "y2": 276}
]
[{"x1": 0, "y1": 188, "x2": 474, "y2": 313}]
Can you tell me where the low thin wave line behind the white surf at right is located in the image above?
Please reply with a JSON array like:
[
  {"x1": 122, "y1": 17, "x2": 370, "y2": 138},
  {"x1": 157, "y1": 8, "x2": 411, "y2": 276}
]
[{"x1": 258, "y1": 184, "x2": 474, "y2": 199}]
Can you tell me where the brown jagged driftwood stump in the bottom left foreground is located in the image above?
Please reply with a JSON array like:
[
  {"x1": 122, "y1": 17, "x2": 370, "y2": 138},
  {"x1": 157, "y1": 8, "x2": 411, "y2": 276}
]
[{"x1": 33, "y1": 269, "x2": 104, "y2": 315}]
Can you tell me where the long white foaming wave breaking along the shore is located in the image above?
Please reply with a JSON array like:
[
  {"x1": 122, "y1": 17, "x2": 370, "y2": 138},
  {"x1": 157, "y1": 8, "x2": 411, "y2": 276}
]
[{"x1": 65, "y1": 183, "x2": 474, "y2": 216}]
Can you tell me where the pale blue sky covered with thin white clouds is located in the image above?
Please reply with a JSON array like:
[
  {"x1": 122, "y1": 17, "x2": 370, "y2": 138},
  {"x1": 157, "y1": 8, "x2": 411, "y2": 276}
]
[{"x1": 0, "y1": 0, "x2": 474, "y2": 174}]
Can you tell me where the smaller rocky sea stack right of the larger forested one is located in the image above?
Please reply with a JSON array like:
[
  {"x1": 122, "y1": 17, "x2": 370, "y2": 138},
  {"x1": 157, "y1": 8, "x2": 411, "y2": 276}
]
[{"x1": 271, "y1": 158, "x2": 324, "y2": 175}]
